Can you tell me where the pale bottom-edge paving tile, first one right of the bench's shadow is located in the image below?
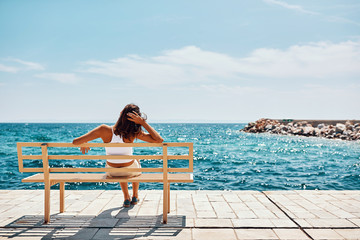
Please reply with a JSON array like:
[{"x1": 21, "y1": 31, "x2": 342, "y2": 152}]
[{"x1": 192, "y1": 228, "x2": 236, "y2": 240}]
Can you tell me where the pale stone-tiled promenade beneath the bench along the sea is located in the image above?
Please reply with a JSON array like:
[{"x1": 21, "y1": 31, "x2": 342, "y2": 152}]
[{"x1": 0, "y1": 190, "x2": 360, "y2": 240}]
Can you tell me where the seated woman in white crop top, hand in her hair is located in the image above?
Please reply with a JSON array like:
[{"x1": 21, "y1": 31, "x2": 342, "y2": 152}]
[{"x1": 73, "y1": 104, "x2": 164, "y2": 207}]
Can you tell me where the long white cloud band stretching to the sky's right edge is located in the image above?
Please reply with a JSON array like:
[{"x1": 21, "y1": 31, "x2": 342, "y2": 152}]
[{"x1": 82, "y1": 41, "x2": 360, "y2": 87}]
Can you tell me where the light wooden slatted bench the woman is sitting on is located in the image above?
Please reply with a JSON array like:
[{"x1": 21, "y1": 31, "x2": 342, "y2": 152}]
[{"x1": 17, "y1": 142, "x2": 193, "y2": 223}]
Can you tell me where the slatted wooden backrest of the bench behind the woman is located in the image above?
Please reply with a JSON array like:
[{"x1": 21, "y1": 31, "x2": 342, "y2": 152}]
[{"x1": 17, "y1": 142, "x2": 193, "y2": 178}]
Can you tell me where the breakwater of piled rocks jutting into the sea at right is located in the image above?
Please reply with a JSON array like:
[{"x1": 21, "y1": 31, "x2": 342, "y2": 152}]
[{"x1": 240, "y1": 118, "x2": 360, "y2": 141}]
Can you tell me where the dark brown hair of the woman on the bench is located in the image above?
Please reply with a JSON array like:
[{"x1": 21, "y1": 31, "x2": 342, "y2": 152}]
[{"x1": 114, "y1": 103, "x2": 146, "y2": 139}]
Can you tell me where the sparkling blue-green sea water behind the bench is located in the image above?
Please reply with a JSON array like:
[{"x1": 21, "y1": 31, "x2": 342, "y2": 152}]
[{"x1": 0, "y1": 123, "x2": 360, "y2": 191}]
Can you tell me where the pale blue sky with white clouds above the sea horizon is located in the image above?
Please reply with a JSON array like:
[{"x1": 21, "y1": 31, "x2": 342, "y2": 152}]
[{"x1": 0, "y1": 0, "x2": 360, "y2": 123}]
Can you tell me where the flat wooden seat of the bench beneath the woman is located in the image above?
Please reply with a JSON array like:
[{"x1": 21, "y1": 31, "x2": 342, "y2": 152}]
[{"x1": 22, "y1": 173, "x2": 194, "y2": 182}]
